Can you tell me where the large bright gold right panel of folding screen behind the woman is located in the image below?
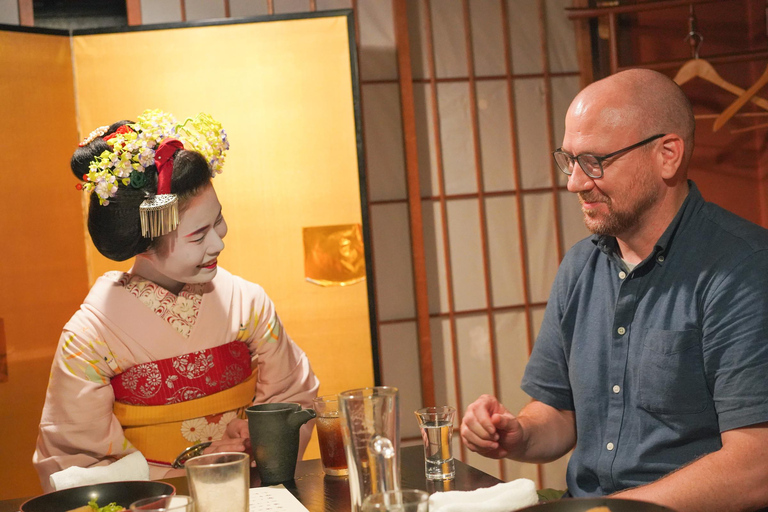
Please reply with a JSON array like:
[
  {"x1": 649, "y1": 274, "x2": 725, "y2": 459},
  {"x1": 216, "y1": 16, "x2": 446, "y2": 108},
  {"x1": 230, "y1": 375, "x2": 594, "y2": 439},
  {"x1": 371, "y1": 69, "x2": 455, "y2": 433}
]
[{"x1": 73, "y1": 15, "x2": 373, "y2": 456}]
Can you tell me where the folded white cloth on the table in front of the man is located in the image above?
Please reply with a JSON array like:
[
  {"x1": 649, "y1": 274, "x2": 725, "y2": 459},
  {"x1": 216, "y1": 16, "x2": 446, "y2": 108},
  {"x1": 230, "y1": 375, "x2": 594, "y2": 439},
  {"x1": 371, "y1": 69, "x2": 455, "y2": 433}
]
[{"x1": 429, "y1": 478, "x2": 539, "y2": 512}]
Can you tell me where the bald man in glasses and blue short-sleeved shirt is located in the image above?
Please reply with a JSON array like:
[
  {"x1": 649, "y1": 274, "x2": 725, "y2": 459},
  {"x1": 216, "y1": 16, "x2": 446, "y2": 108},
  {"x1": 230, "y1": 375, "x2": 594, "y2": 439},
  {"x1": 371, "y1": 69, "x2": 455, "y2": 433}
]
[{"x1": 461, "y1": 70, "x2": 768, "y2": 512}]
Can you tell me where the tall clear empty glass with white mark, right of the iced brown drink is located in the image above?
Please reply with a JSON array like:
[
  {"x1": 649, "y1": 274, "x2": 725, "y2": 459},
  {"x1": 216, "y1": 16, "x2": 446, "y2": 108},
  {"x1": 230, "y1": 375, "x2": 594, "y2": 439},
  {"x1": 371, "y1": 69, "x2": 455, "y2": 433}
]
[{"x1": 339, "y1": 386, "x2": 400, "y2": 512}]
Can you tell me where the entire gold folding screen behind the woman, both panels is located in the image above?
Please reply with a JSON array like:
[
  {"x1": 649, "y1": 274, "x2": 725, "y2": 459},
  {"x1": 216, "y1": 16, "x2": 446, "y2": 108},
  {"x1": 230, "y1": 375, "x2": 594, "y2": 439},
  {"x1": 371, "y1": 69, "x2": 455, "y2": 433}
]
[{"x1": 0, "y1": 11, "x2": 374, "y2": 498}]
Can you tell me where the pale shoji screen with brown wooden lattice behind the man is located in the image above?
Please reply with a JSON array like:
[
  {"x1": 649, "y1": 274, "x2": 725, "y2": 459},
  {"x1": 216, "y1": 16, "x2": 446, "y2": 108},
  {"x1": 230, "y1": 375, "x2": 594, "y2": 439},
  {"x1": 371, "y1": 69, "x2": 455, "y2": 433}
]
[{"x1": 355, "y1": 0, "x2": 587, "y2": 487}]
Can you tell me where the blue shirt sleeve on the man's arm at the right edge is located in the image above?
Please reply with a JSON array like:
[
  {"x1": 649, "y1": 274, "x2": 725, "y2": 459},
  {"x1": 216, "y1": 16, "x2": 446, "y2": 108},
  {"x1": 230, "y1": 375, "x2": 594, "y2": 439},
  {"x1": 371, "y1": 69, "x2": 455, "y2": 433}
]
[{"x1": 702, "y1": 250, "x2": 768, "y2": 432}]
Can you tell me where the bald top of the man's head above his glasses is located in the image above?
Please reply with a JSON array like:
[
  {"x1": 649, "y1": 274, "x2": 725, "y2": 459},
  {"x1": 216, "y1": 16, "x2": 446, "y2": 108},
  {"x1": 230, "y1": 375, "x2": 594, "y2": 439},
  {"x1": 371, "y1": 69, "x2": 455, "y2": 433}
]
[{"x1": 569, "y1": 69, "x2": 695, "y2": 170}]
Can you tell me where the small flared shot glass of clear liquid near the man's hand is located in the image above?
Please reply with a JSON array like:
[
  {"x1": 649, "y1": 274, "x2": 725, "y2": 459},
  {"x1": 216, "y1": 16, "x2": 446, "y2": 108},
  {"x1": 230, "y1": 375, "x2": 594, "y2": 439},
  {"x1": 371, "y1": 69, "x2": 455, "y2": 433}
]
[{"x1": 415, "y1": 405, "x2": 456, "y2": 480}]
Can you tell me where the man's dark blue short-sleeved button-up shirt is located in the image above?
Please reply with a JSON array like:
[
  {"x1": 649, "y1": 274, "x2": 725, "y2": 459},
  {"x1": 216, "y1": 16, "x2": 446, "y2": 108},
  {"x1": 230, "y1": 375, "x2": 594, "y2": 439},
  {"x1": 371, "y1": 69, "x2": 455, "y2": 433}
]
[{"x1": 522, "y1": 182, "x2": 768, "y2": 496}]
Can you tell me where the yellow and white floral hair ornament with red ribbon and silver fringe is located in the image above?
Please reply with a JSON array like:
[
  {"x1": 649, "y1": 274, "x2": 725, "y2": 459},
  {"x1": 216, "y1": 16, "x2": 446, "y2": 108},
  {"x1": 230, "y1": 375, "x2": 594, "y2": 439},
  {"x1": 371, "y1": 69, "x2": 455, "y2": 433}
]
[{"x1": 77, "y1": 110, "x2": 229, "y2": 238}]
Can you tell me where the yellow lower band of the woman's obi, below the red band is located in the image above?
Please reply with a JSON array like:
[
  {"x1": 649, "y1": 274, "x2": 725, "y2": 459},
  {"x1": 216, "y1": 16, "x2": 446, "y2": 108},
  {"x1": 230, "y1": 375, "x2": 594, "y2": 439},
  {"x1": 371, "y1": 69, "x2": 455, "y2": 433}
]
[{"x1": 112, "y1": 369, "x2": 257, "y2": 465}]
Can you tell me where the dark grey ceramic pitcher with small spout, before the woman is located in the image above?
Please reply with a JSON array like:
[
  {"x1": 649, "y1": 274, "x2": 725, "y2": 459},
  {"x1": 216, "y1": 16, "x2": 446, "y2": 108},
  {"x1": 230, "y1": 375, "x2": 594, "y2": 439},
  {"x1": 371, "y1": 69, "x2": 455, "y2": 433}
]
[{"x1": 245, "y1": 402, "x2": 316, "y2": 485}]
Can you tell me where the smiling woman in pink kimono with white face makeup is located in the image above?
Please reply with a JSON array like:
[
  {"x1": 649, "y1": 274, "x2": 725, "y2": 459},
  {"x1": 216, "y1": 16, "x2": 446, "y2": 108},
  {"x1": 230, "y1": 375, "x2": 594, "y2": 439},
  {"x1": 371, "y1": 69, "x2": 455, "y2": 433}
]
[{"x1": 33, "y1": 111, "x2": 319, "y2": 491}]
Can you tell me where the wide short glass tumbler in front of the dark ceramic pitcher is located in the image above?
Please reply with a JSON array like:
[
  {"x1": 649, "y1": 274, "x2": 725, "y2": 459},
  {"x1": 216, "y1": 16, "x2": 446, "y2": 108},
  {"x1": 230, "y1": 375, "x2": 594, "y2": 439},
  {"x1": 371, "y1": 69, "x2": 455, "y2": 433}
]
[{"x1": 184, "y1": 452, "x2": 251, "y2": 512}]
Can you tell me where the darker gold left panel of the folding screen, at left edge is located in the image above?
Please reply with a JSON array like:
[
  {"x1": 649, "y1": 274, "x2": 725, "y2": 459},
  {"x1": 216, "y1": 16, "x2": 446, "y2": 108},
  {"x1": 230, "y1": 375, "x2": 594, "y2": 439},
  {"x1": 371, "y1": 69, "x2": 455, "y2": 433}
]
[{"x1": 0, "y1": 31, "x2": 88, "y2": 499}]
